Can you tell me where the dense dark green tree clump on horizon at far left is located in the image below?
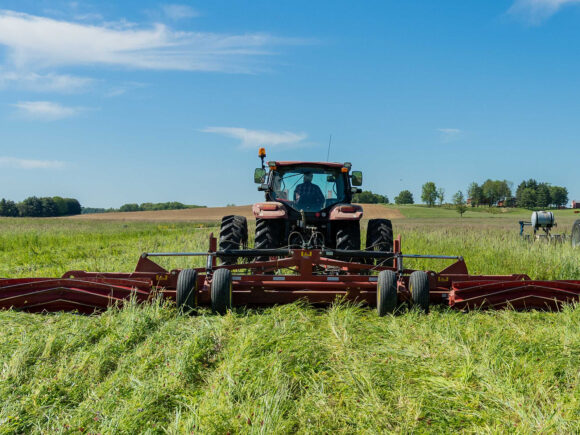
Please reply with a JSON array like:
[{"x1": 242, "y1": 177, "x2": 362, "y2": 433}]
[{"x1": 0, "y1": 196, "x2": 81, "y2": 217}]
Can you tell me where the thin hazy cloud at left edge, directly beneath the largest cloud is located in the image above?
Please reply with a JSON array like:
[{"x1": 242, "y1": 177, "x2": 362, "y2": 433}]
[{"x1": 0, "y1": 69, "x2": 95, "y2": 93}]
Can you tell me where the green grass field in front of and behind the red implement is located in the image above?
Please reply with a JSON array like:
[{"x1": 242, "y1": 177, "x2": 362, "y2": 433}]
[{"x1": 0, "y1": 207, "x2": 580, "y2": 433}]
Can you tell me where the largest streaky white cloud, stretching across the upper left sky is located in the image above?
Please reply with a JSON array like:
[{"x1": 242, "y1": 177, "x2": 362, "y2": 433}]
[{"x1": 0, "y1": 10, "x2": 304, "y2": 73}]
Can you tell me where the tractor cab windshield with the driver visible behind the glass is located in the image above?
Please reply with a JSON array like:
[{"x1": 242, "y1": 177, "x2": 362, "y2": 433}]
[{"x1": 271, "y1": 166, "x2": 345, "y2": 211}]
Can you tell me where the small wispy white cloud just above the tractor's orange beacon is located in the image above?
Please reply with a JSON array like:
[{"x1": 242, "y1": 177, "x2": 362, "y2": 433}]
[{"x1": 202, "y1": 127, "x2": 308, "y2": 148}]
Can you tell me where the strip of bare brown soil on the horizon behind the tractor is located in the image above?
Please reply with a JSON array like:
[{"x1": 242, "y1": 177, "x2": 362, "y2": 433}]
[{"x1": 62, "y1": 204, "x2": 404, "y2": 222}]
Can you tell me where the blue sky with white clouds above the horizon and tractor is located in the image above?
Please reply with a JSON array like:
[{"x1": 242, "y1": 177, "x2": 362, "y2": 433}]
[{"x1": 0, "y1": 0, "x2": 580, "y2": 207}]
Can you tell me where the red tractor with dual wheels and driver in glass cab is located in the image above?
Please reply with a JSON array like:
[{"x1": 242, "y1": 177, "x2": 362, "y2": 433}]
[{"x1": 219, "y1": 148, "x2": 393, "y2": 264}]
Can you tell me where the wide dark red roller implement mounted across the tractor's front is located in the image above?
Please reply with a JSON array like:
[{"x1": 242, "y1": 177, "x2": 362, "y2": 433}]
[{"x1": 0, "y1": 235, "x2": 580, "y2": 313}]
